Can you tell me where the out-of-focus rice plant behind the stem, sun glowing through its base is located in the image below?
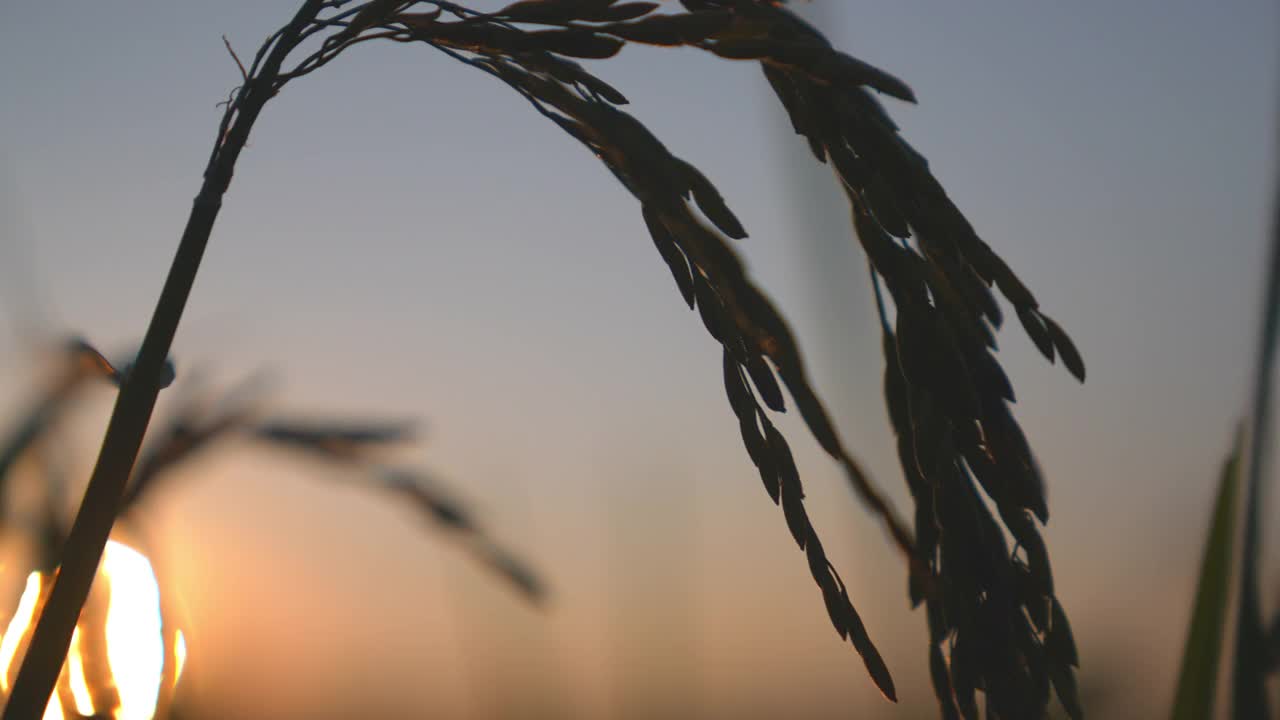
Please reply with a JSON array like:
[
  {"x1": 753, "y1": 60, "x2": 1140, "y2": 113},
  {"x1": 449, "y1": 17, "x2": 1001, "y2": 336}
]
[{"x1": 0, "y1": 337, "x2": 547, "y2": 720}]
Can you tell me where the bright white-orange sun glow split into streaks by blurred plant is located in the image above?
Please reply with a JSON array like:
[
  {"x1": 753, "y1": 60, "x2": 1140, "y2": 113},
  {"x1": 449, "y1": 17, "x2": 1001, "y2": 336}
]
[{"x1": 0, "y1": 541, "x2": 187, "y2": 720}]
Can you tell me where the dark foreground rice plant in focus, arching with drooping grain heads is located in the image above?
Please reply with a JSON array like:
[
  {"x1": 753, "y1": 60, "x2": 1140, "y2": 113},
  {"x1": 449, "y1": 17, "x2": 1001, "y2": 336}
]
[{"x1": 5, "y1": 0, "x2": 1084, "y2": 719}]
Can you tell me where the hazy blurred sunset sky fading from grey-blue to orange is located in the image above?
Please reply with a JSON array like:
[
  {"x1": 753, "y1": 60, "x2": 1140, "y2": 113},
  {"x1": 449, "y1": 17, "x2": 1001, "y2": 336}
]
[{"x1": 0, "y1": 0, "x2": 1280, "y2": 719}]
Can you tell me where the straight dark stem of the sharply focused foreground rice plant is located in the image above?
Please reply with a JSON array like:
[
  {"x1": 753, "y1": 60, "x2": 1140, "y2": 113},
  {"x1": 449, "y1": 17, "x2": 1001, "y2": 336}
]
[{"x1": 4, "y1": 0, "x2": 324, "y2": 720}]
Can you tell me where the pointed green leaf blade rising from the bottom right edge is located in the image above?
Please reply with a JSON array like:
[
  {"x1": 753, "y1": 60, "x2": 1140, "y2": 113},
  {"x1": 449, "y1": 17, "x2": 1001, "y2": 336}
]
[{"x1": 1172, "y1": 429, "x2": 1243, "y2": 720}]
